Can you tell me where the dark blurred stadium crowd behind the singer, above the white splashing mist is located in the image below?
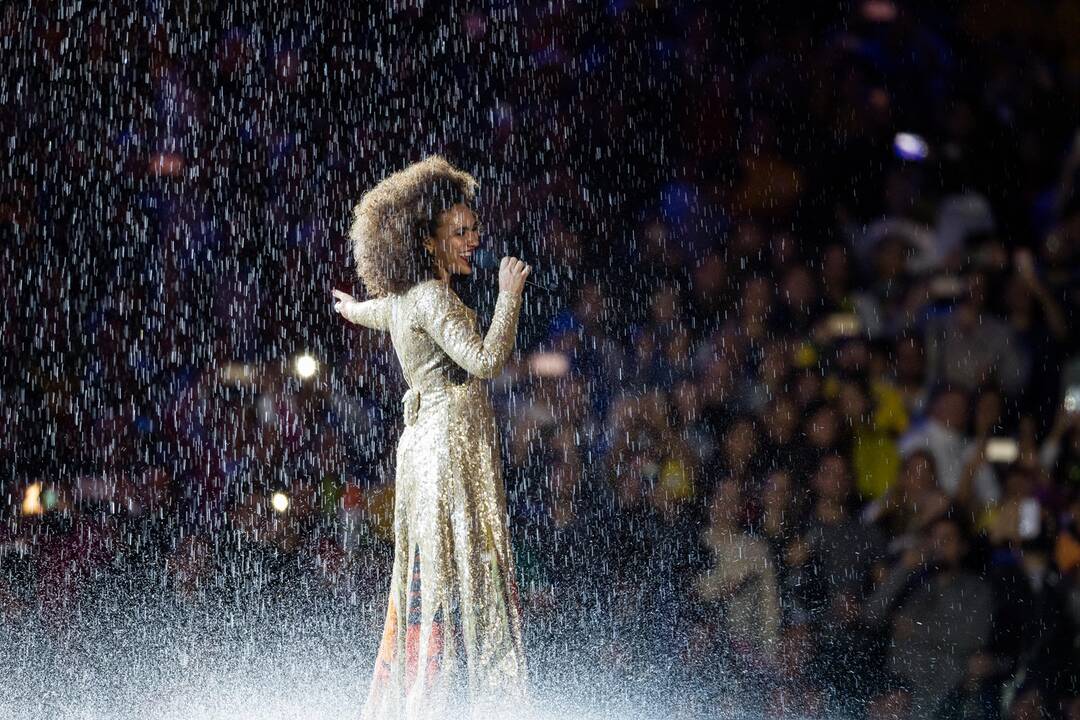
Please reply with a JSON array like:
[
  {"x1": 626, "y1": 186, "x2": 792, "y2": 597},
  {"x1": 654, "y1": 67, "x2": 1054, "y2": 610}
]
[{"x1": 0, "y1": 0, "x2": 1080, "y2": 720}]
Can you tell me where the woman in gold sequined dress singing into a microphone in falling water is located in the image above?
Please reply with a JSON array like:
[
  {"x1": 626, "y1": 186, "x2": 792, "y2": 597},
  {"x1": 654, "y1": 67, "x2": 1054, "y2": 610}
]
[{"x1": 334, "y1": 155, "x2": 530, "y2": 720}]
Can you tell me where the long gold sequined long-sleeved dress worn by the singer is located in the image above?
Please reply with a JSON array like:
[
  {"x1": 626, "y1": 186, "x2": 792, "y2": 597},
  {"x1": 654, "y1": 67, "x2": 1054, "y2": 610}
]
[{"x1": 341, "y1": 280, "x2": 527, "y2": 720}]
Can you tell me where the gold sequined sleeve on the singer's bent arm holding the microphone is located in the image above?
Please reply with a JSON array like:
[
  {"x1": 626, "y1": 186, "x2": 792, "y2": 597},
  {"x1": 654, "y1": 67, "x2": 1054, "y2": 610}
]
[{"x1": 417, "y1": 283, "x2": 522, "y2": 378}]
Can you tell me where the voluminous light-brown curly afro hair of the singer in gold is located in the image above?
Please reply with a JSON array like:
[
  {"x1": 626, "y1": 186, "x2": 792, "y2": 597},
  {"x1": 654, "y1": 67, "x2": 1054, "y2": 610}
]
[{"x1": 349, "y1": 154, "x2": 477, "y2": 297}]
